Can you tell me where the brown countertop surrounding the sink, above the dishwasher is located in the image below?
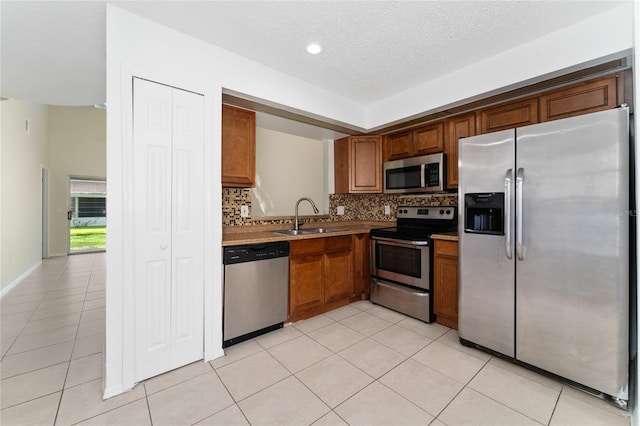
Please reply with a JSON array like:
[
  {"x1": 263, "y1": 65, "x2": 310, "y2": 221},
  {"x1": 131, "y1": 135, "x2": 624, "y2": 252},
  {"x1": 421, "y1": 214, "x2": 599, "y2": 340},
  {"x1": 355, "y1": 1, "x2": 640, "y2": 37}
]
[{"x1": 222, "y1": 221, "x2": 395, "y2": 247}]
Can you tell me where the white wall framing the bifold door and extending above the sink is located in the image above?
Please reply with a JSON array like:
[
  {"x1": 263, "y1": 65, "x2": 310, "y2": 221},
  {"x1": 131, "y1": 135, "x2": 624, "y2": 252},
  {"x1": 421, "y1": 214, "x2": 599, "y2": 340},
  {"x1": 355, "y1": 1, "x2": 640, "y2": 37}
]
[{"x1": 104, "y1": 5, "x2": 380, "y2": 397}]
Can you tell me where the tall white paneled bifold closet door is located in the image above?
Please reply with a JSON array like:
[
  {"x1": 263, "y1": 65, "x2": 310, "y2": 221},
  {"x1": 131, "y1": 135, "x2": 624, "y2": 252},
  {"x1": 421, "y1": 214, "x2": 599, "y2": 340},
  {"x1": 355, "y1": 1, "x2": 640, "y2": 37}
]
[{"x1": 133, "y1": 79, "x2": 204, "y2": 381}]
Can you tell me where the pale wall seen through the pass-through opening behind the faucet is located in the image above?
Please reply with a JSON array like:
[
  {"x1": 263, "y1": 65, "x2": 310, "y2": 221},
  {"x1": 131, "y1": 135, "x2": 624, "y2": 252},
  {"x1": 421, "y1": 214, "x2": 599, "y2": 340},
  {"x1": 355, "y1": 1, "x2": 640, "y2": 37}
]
[{"x1": 251, "y1": 127, "x2": 324, "y2": 218}]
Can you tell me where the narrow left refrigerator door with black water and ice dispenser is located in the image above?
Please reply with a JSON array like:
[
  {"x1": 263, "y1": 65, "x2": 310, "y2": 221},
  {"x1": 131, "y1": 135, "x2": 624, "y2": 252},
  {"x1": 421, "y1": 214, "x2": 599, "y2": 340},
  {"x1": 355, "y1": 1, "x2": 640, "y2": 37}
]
[{"x1": 458, "y1": 130, "x2": 515, "y2": 357}]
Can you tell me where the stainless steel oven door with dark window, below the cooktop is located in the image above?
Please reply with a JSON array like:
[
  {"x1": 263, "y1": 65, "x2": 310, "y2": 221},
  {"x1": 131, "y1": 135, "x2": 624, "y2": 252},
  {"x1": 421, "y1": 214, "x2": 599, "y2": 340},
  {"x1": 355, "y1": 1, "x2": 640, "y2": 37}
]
[{"x1": 371, "y1": 237, "x2": 431, "y2": 291}]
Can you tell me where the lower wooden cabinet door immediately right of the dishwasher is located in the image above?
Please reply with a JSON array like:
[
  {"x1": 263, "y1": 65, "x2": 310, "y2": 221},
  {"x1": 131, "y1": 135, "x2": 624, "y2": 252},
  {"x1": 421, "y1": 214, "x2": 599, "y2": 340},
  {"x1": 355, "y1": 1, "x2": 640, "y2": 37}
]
[{"x1": 289, "y1": 254, "x2": 324, "y2": 315}]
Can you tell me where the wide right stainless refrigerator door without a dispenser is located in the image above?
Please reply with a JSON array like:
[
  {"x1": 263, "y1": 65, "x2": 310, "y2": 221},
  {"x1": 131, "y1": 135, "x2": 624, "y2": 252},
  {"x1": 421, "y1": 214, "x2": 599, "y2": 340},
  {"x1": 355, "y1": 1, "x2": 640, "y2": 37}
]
[{"x1": 516, "y1": 109, "x2": 629, "y2": 399}]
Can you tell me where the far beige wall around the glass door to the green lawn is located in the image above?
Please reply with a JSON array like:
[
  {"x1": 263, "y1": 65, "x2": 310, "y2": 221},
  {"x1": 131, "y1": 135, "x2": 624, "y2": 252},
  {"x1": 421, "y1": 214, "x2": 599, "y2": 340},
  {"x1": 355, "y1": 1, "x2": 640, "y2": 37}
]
[{"x1": 49, "y1": 106, "x2": 108, "y2": 256}]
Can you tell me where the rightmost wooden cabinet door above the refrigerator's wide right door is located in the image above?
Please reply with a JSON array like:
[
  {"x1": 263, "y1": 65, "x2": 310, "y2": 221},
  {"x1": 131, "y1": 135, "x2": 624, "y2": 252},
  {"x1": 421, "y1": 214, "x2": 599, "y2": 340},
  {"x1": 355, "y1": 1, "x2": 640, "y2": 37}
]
[{"x1": 540, "y1": 75, "x2": 618, "y2": 121}]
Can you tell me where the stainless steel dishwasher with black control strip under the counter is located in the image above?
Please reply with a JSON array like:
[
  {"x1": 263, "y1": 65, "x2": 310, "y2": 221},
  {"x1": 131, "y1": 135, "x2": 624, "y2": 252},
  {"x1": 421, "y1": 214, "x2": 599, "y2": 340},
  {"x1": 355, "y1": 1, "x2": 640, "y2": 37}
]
[{"x1": 222, "y1": 241, "x2": 289, "y2": 348}]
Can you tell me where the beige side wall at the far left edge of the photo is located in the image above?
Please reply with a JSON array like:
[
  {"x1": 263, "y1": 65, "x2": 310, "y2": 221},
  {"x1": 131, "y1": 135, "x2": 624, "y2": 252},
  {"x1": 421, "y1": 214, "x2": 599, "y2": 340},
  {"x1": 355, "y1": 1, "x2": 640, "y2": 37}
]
[{"x1": 0, "y1": 100, "x2": 49, "y2": 291}]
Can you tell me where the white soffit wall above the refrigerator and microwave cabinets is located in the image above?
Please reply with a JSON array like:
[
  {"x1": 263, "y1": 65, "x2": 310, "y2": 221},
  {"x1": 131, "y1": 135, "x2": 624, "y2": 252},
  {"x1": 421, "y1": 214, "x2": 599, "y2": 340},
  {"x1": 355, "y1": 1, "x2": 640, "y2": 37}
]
[{"x1": 359, "y1": 2, "x2": 633, "y2": 129}]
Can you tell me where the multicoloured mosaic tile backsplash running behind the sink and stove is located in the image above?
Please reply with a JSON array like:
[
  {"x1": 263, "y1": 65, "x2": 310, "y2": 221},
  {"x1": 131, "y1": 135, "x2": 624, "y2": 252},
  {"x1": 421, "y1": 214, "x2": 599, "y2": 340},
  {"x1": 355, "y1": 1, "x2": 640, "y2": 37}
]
[{"x1": 222, "y1": 188, "x2": 458, "y2": 226}]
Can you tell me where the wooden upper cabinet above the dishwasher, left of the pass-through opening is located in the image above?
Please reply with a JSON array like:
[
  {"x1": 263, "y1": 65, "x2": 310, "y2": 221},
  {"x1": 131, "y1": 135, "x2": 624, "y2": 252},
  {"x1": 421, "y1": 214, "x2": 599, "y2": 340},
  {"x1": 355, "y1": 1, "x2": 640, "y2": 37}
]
[{"x1": 222, "y1": 105, "x2": 256, "y2": 188}]
